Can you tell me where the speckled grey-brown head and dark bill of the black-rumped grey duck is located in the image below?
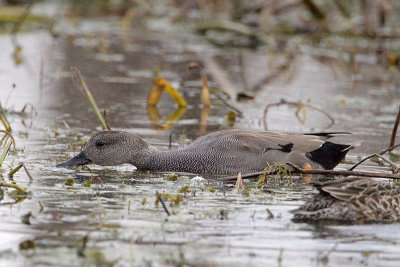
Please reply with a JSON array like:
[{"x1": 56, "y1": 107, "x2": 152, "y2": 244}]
[{"x1": 57, "y1": 131, "x2": 152, "y2": 167}]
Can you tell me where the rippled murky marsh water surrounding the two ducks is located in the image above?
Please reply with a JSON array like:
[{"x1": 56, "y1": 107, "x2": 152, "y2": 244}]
[{"x1": 0, "y1": 6, "x2": 400, "y2": 266}]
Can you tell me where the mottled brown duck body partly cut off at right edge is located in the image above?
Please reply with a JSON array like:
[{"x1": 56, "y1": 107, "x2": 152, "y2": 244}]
[{"x1": 292, "y1": 178, "x2": 400, "y2": 223}]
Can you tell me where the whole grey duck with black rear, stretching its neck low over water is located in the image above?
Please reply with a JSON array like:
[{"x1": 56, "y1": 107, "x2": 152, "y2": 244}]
[{"x1": 57, "y1": 129, "x2": 352, "y2": 175}]
